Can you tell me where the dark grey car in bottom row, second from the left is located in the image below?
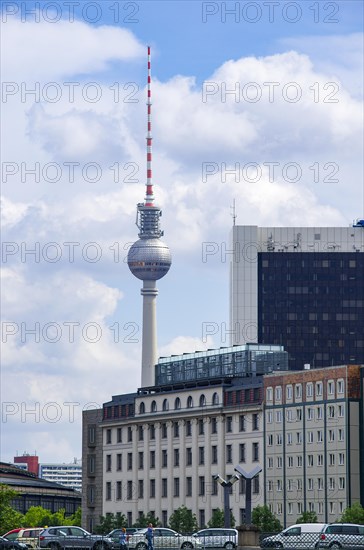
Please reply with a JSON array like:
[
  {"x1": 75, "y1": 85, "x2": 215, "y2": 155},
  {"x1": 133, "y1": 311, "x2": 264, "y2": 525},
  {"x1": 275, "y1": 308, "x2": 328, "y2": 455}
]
[{"x1": 39, "y1": 525, "x2": 118, "y2": 550}]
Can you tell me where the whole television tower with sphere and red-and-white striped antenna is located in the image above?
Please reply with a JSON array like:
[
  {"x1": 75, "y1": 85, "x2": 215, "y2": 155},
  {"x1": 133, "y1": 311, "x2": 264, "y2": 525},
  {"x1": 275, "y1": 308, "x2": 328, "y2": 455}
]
[{"x1": 128, "y1": 46, "x2": 172, "y2": 387}]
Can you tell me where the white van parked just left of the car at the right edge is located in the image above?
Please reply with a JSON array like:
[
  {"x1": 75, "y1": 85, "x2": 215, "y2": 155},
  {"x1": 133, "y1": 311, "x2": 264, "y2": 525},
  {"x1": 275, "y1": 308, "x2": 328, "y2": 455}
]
[{"x1": 260, "y1": 523, "x2": 327, "y2": 550}]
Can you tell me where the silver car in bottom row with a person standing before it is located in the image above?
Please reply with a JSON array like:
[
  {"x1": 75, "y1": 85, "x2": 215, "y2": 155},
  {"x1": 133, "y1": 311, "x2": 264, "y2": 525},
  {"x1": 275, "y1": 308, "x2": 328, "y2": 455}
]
[{"x1": 128, "y1": 527, "x2": 202, "y2": 550}]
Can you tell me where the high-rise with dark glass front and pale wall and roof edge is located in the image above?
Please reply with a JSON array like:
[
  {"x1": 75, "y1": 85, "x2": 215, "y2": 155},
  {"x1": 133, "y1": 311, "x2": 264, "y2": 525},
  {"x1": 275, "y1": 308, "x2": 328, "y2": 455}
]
[{"x1": 230, "y1": 225, "x2": 364, "y2": 370}]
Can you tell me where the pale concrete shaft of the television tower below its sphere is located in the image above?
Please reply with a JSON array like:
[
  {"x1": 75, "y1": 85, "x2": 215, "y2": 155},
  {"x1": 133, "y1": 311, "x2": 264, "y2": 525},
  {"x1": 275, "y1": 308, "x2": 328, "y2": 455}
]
[{"x1": 140, "y1": 281, "x2": 158, "y2": 387}]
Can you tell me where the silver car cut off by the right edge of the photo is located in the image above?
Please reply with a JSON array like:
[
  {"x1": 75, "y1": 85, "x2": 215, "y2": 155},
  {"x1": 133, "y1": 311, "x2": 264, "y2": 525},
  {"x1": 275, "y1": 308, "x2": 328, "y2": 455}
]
[{"x1": 318, "y1": 523, "x2": 364, "y2": 550}]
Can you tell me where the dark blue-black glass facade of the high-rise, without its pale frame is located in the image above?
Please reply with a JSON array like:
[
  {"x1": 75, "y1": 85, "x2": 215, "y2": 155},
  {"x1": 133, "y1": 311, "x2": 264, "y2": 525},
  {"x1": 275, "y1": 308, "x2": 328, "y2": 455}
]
[{"x1": 258, "y1": 251, "x2": 364, "y2": 370}]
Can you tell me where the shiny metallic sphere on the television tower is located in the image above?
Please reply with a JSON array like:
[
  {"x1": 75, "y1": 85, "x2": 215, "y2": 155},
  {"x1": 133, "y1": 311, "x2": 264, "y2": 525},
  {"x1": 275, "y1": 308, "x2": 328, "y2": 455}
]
[{"x1": 128, "y1": 239, "x2": 172, "y2": 281}]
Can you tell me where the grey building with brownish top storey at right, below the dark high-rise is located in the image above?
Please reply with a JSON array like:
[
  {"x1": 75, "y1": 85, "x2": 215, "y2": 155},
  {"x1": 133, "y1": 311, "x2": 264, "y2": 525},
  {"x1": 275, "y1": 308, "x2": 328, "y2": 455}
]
[{"x1": 264, "y1": 365, "x2": 364, "y2": 526}]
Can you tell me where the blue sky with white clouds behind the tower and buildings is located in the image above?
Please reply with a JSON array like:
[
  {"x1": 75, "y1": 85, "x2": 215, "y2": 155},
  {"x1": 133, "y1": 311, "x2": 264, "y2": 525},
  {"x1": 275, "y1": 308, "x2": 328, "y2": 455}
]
[{"x1": 1, "y1": 0, "x2": 364, "y2": 462}]
